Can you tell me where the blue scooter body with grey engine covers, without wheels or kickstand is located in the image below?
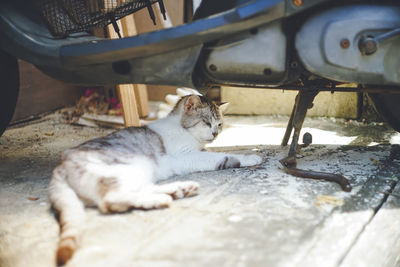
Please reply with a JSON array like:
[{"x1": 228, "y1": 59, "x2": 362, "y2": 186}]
[{"x1": 0, "y1": 0, "x2": 400, "y2": 90}]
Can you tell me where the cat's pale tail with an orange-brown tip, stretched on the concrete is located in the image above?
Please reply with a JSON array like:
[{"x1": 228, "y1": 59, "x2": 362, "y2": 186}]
[{"x1": 49, "y1": 166, "x2": 85, "y2": 266}]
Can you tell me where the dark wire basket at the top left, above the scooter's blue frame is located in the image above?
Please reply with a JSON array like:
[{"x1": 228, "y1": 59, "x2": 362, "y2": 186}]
[{"x1": 36, "y1": 0, "x2": 165, "y2": 37}]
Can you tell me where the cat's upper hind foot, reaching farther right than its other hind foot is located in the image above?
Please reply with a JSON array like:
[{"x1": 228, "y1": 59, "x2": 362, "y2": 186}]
[{"x1": 153, "y1": 181, "x2": 200, "y2": 199}]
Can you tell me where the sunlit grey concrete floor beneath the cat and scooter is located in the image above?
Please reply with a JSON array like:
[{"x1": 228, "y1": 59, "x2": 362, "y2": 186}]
[{"x1": 0, "y1": 113, "x2": 400, "y2": 267}]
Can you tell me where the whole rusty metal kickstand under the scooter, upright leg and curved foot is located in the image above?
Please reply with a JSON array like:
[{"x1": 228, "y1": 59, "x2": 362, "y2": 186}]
[{"x1": 279, "y1": 90, "x2": 351, "y2": 192}]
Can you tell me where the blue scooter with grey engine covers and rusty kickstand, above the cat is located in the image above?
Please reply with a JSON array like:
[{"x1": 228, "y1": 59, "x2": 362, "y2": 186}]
[{"x1": 0, "y1": 0, "x2": 400, "y2": 191}]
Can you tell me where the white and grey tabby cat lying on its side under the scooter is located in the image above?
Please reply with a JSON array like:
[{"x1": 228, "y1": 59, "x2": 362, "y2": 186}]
[{"x1": 49, "y1": 95, "x2": 262, "y2": 265}]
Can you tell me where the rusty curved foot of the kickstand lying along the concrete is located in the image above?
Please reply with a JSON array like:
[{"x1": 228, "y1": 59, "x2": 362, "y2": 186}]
[{"x1": 279, "y1": 156, "x2": 352, "y2": 192}]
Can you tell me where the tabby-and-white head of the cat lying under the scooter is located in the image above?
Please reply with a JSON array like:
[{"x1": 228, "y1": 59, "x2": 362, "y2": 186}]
[{"x1": 172, "y1": 95, "x2": 228, "y2": 143}]
